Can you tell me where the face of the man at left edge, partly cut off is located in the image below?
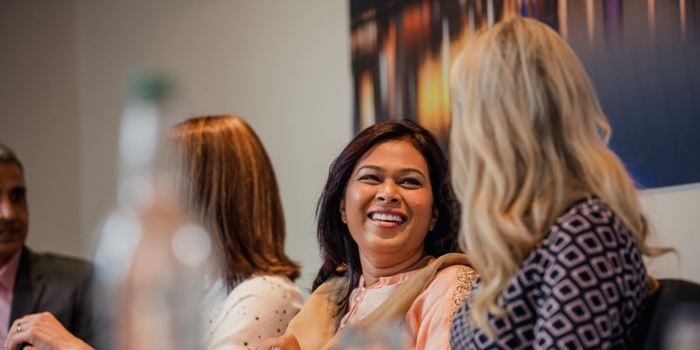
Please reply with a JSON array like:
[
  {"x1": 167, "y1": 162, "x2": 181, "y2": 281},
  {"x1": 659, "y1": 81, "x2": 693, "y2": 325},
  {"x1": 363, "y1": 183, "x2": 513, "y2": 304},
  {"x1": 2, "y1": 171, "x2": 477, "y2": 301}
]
[{"x1": 0, "y1": 162, "x2": 29, "y2": 265}]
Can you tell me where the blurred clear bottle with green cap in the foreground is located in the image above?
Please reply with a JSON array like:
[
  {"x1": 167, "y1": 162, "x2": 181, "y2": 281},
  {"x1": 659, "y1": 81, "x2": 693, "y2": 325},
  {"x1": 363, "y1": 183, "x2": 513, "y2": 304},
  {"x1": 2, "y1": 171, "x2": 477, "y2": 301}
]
[{"x1": 96, "y1": 73, "x2": 211, "y2": 349}]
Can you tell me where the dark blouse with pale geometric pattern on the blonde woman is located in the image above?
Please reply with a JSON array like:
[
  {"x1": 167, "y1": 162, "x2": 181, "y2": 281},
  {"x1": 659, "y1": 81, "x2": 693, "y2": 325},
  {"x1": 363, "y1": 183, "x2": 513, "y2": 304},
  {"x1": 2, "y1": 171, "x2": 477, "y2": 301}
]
[{"x1": 450, "y1": 197, "x2": 648, "y2": 349}]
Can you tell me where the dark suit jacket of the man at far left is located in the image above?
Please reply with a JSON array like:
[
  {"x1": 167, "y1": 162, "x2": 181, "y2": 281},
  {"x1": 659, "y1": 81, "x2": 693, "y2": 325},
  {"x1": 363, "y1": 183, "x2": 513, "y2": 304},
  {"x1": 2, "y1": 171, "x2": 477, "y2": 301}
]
[{"x1": 10, "y1": 247, "x2": 97, "y2": 347}]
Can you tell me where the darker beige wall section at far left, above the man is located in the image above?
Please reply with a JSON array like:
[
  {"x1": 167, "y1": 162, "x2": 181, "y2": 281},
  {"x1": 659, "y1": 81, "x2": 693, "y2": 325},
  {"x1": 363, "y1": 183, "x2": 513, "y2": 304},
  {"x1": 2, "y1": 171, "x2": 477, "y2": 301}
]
[{"x1": 0, "y1": 0, "x2": 85, "y2": 255}]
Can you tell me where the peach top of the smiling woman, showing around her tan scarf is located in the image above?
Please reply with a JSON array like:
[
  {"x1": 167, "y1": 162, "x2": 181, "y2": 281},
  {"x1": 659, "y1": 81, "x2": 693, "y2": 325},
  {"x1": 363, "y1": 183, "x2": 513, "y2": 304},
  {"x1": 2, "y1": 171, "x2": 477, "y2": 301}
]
[{"x1": 339, "y1": 265, "x2": 476, "y2": 349}]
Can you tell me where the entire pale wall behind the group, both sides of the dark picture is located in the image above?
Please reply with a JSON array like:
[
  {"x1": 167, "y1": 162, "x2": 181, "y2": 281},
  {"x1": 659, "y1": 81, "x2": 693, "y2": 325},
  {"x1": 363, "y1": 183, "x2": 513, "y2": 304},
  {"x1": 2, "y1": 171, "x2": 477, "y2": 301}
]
[{"x1": 0, "y1": 0, "x2": 700, "y2": 287}]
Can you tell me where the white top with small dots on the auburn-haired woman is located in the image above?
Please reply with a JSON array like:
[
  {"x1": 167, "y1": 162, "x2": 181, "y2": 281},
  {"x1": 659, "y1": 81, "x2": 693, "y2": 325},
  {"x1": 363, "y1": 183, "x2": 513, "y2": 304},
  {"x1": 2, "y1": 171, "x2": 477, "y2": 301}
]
[{"x1": 202, "y1": 276, "x2": 304, "y2": 350}]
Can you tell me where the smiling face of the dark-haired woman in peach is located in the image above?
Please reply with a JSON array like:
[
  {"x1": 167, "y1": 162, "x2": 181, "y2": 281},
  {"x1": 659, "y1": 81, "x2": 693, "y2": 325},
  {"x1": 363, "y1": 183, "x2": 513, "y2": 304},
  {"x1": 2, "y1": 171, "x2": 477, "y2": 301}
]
[{"x1": 340, "y1": 140, "x2": 437, "y2": 261}]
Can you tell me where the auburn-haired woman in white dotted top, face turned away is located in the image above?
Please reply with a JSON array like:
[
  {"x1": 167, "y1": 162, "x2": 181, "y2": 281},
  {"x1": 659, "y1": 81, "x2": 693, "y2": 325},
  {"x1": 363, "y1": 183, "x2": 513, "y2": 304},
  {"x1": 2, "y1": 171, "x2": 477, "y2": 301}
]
[{"x1": 171, "y1": 115, "x2": 303, "y2": 349}]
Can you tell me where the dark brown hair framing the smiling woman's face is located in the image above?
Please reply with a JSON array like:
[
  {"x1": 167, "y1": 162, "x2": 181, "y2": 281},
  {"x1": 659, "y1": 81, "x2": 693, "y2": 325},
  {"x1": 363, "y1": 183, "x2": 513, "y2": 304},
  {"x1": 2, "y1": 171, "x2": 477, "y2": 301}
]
[{"x1": 313, "y1": 120, "x2": 460, "y2": 322}]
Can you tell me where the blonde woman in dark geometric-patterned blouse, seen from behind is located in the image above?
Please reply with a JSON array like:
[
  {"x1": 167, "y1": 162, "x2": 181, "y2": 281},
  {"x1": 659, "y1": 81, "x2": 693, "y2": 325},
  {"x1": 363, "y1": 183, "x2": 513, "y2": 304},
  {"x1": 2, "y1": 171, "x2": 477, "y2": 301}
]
[{"x1": 451, "y1": 18, "x2": 667, "y2": 349}]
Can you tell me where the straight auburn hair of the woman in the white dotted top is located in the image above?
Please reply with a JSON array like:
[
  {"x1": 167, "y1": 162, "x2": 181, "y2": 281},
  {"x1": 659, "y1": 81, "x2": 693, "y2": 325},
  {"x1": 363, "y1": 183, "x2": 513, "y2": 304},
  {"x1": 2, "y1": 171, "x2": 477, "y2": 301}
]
[{"x1": 171, "y1": 115, "x2": 299, "y2": 290}]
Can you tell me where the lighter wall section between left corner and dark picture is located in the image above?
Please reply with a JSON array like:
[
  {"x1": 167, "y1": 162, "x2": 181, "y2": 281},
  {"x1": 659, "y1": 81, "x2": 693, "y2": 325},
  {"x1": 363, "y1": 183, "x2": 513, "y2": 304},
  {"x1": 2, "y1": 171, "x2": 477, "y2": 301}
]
[{"x1": 79, "y1": 0, "x2": 352, "y2": 286}]
